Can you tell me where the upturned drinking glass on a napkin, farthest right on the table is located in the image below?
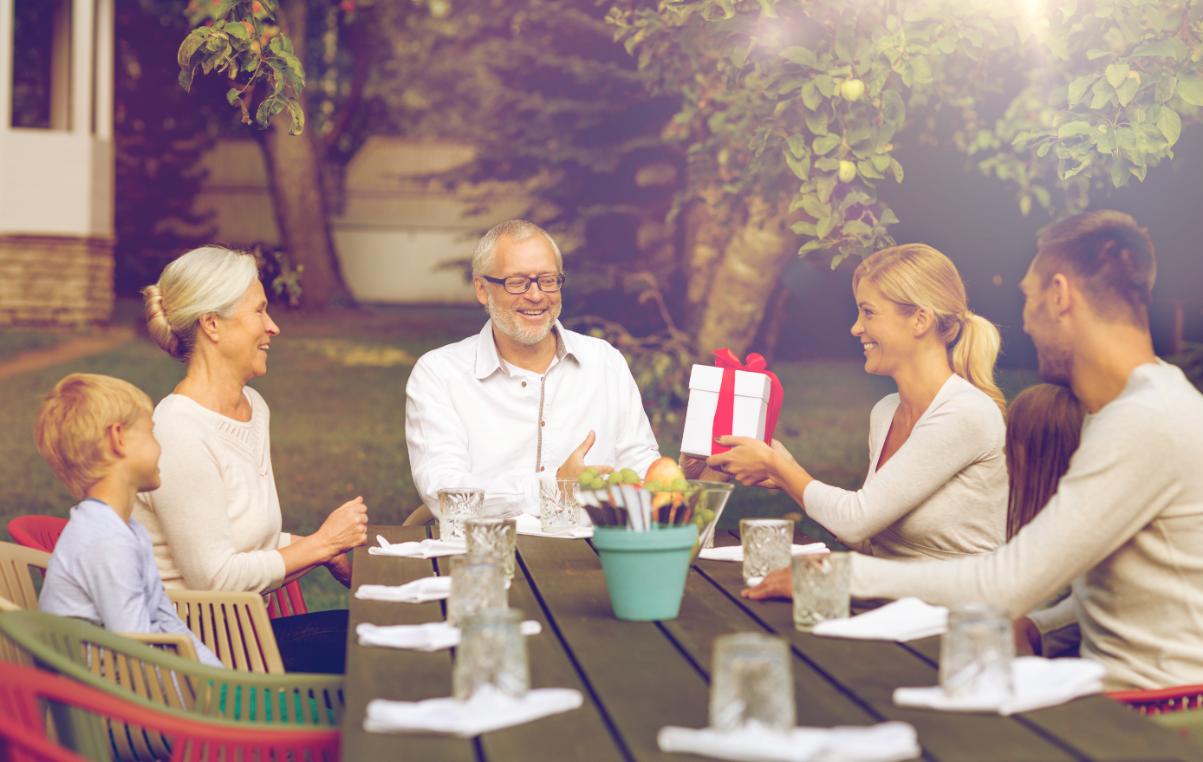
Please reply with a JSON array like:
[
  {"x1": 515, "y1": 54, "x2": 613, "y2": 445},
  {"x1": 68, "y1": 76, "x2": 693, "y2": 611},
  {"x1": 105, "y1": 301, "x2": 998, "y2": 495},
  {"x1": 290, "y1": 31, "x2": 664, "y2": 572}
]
[{"x1": 940, "y1": 603, "x2": 1015, "y2": 701}]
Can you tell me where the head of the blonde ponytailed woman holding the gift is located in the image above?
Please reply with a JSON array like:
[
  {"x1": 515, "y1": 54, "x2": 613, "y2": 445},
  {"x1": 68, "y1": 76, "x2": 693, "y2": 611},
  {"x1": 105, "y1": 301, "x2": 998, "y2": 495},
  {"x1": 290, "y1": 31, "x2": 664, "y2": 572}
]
[{"x1": 852, "y1": 243, "x2": 1006, "y2": 408}]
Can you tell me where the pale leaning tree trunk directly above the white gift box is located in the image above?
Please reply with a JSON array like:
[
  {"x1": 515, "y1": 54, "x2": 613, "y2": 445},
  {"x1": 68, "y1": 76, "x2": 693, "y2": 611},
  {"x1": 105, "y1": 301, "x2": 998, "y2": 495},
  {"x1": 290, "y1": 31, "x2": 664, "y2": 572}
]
[{"x1": 698, "y1": 197, "x2": 794, "y2": 356}]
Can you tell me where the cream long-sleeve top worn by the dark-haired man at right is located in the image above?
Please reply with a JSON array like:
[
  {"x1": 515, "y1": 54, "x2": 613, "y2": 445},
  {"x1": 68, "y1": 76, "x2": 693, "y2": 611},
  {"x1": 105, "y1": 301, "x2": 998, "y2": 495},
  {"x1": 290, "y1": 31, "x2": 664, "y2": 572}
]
[{"x1": 852, "y1": 362, "x2": 1203, "y2": 690}]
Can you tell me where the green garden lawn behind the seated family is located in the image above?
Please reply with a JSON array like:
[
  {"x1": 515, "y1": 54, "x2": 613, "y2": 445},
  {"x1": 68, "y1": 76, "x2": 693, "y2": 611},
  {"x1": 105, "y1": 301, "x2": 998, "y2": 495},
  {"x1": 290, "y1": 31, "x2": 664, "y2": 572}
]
[{"x1": 0, "y1": 299, "x2": 1035, "y2": 610}]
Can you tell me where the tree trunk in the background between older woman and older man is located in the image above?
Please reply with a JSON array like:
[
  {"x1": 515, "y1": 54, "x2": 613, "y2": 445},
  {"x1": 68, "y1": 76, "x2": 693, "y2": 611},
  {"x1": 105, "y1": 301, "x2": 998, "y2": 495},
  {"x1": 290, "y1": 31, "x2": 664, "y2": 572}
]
[{"x1": 259, "y1": 2, "x2": 350, "y2": 309}]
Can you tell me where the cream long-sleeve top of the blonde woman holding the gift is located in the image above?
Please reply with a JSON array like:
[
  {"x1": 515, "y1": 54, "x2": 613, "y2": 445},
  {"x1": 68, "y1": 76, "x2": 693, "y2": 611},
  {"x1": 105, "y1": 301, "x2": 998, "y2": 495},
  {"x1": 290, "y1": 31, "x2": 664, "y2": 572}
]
[{"x1": 802, "y1": 373, "x2": 1007, "y2": 559}]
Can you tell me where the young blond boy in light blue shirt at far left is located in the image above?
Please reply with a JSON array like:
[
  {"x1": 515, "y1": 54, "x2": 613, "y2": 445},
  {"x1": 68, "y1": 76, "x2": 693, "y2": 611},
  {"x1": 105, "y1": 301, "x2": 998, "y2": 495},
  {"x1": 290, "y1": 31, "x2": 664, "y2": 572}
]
[{"x1": 34, "y1": 373, "x2": 221, "y2": 667}]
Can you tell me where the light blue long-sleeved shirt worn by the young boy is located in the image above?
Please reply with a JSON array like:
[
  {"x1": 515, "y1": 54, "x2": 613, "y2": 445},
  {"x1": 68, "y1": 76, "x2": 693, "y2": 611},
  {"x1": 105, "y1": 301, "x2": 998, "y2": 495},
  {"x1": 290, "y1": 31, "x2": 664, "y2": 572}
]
[{"x1": 37, "y1": 497, "x2": 223, "y2": 667}]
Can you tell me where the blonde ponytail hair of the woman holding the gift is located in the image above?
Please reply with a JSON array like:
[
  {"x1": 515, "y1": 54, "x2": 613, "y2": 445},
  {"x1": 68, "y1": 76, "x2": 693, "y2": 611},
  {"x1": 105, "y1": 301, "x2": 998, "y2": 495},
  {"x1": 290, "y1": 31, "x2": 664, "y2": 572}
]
[{"x1": 852, "y1": 243, "x2": 1007, "y2": 410}]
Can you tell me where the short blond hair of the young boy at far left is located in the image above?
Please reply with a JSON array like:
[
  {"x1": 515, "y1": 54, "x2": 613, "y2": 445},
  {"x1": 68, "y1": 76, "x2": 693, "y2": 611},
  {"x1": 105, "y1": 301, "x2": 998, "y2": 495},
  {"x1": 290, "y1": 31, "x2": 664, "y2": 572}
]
[{"x1": 34, "y1": 373, "x2": 154, "y2": 500}]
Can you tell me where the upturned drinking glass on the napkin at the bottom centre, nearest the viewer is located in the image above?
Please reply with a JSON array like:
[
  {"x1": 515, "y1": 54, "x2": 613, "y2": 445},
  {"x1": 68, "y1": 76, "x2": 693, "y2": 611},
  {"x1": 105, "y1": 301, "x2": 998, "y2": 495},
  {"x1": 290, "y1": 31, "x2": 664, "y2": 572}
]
[{"x1": 710, "y1": 632, "x2": 794, "y2": 731}]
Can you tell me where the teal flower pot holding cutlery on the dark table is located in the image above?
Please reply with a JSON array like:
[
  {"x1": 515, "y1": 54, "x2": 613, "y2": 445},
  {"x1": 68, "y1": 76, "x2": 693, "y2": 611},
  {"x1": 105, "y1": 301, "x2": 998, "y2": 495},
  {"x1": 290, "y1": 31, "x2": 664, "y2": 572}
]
[{"x1": 593, "y1": 524, "x2": 698, "y2": 621}]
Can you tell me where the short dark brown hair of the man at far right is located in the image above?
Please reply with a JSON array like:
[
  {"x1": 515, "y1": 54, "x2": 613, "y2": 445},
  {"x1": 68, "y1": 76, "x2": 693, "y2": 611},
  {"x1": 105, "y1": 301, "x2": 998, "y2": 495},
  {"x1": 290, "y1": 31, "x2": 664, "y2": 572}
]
[{"x1": 1032, "y1": 209, "x2": 1157, "y2": 327}]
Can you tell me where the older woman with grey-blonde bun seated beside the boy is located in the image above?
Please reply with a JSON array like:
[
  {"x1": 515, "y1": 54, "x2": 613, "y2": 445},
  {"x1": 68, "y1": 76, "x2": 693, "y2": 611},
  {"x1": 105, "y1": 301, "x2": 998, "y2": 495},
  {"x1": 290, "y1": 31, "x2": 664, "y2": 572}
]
[{"x1": 135, "y1": 246, "x2": 367, "y2": 672}]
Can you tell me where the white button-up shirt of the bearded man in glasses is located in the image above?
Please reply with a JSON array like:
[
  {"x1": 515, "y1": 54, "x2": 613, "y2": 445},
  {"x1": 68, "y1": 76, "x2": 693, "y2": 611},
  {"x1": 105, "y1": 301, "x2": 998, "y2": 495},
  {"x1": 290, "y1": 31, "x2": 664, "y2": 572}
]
[{"x1": 405, "y1": 320, "x2": 659, "y2": 515}]
